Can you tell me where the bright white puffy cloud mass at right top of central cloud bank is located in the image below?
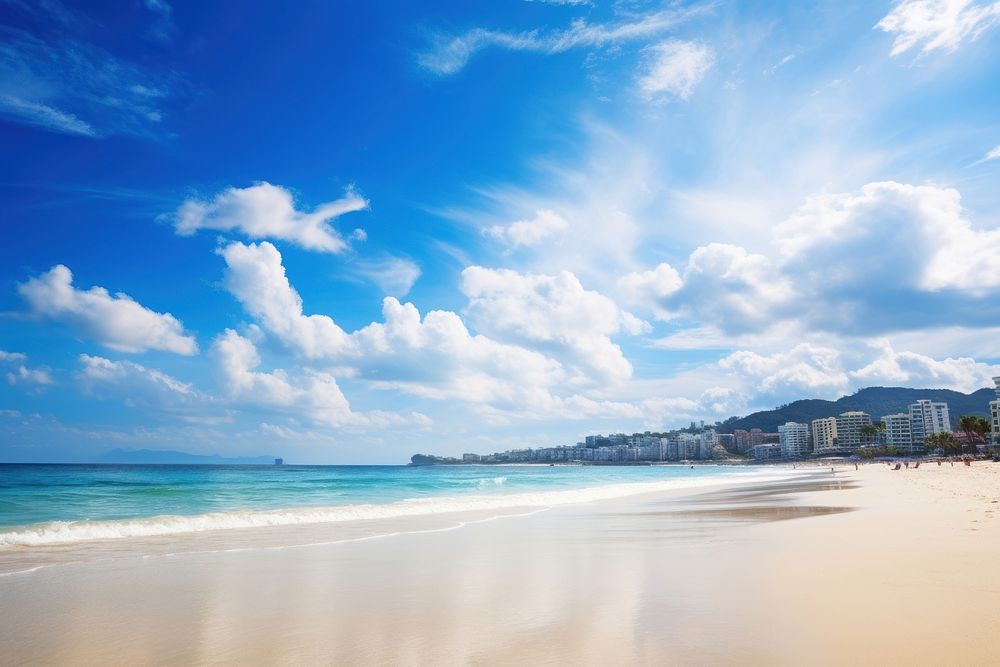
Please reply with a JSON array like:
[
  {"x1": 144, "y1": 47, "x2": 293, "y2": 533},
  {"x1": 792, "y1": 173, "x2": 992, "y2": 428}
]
[{"x1": 462, "y1": 266, "x2": 646, "y2": 382}]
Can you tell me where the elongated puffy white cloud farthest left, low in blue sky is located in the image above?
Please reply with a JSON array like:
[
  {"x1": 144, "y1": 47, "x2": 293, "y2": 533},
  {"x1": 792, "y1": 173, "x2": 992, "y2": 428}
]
[{"x1": 17, "y1": 264, "x2": 198, "y2": 355}]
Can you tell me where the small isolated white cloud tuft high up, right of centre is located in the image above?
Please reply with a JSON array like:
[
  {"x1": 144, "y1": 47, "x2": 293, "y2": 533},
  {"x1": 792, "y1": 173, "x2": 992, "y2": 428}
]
[{"x1": 639, "y1": 40, "x2": 715, "y2": 100}]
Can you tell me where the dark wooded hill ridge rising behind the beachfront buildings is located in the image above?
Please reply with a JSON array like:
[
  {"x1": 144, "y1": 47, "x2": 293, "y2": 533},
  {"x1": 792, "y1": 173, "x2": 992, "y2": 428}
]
[{"x1": 720, "y1": 387, "x2": 996, "y2": 433}]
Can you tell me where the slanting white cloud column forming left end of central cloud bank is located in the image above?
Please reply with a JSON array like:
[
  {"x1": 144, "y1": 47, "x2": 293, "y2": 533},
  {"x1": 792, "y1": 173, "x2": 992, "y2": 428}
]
[{"x1": 218, "y1": 241, "x2": 350, "y2": 358}]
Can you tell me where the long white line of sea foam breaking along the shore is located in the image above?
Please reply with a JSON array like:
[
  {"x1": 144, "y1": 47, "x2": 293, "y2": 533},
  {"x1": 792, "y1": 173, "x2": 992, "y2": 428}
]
[{"x1": 0, "y1": 471, "x2": 791, "y2": 549}]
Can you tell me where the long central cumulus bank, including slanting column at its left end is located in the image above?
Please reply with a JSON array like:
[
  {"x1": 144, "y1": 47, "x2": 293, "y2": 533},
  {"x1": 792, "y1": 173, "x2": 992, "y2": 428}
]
[{"x1": 220, "y1": 242, "x2": 642, "y2": 418}]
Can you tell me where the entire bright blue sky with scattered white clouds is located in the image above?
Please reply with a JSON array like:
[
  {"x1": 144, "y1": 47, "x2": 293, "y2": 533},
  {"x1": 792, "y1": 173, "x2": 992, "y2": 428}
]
[{"x1": 0, "y1": 0, "x2": 1000, "y2": 463}]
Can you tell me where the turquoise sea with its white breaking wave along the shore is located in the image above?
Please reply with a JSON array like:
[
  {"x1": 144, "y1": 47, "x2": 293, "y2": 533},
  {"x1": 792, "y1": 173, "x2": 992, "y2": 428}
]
[{"x1": 0, "y1": 464, "x2": 786, "y2": 552}]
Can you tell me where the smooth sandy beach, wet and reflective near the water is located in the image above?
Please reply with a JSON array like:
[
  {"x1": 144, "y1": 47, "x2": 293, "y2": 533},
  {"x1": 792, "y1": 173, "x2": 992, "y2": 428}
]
[{"x1": 0, "y1": 462, "x2": 1000, "y2": 665}]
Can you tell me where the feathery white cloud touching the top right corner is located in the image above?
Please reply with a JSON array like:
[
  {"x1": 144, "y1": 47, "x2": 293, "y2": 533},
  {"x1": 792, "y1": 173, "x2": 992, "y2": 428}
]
[{"x1": 875, "y1": 0, "x2": 1000, "y2": 56}]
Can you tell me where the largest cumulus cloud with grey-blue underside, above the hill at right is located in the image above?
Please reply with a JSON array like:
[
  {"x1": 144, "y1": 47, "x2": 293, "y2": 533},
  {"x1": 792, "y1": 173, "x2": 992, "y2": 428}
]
[{"x1": 622, "y1": 182, "x2": 1000, "y2": 335}]
